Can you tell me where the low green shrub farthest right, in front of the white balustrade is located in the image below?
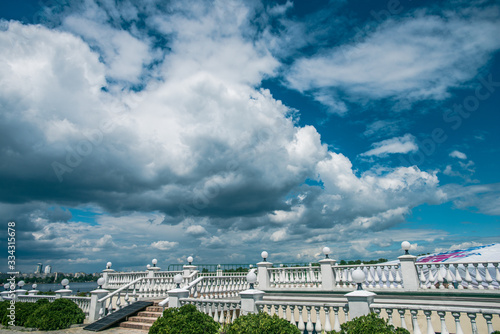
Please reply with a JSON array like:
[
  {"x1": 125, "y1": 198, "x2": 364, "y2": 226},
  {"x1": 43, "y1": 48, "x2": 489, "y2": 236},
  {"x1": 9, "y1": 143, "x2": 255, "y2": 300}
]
[{"x1": 329, "y1": 313, "x2": 410, "y2": 334}]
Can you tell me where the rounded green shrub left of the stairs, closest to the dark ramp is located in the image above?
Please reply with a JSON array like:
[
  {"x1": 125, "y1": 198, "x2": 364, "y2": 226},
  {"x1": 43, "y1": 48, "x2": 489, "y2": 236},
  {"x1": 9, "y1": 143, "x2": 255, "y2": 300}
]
[{"x1": 26, "y1": 298, "x2": 85, "y2": 330}]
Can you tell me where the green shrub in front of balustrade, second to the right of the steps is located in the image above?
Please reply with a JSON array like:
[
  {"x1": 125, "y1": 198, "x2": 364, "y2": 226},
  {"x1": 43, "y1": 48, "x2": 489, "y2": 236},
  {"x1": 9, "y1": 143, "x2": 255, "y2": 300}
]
[{"x1": 224, "y1": 312, "x2": 300, "y2": 334}]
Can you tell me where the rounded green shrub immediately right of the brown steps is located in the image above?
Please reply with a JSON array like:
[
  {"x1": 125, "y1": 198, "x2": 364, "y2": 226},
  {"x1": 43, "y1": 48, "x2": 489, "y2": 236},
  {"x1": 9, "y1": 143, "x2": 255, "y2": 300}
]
[{"x1": 149, "y1": 304, "x2": 220, "y2": 334}]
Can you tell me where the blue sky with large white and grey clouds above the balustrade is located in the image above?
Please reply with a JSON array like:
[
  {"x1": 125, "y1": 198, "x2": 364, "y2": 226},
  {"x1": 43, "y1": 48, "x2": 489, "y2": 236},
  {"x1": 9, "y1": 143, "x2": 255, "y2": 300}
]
[{"x1": 0, "y1": 0, "x2": 500, "y2": 272}]
